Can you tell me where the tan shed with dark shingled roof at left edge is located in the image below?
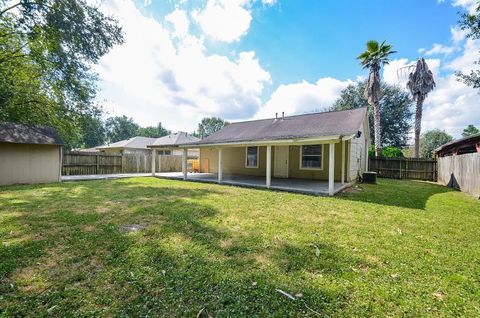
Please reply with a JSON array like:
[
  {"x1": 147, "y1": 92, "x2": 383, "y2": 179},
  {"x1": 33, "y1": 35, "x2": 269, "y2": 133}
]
[{"x1": 0, "y1": 123, "x2": 63, "y2": 185}]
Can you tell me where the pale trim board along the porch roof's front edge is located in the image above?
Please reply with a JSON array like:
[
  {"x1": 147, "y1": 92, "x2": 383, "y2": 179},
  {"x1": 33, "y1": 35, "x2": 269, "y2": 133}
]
[{"x1": 178, "y1": 135, "x2": 344, "y2": 148}]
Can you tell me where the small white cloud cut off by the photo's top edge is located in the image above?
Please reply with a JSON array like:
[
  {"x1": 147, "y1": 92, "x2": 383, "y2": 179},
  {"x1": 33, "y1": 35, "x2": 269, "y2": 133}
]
[{"x1": 192, "y1": 0, "x2": 252, "y2": 42}]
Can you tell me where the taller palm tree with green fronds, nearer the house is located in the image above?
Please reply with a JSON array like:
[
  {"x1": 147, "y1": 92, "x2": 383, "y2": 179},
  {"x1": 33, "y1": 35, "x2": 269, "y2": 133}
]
[{"x1": 357, "y1": 40, "x2": 396, "y2": 157}]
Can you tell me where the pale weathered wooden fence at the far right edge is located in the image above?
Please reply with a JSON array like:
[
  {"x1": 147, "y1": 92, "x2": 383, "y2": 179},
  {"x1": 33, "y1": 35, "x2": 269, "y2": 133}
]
[{"x1": 438, "y1": 153, "x2": 480, "y2": 198}]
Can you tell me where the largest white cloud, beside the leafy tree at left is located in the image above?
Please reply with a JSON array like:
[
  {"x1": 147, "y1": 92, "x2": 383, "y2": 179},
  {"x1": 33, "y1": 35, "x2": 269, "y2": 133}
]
[{"x1": 97, "y1": 0, "x2": 270, "y2": 131}]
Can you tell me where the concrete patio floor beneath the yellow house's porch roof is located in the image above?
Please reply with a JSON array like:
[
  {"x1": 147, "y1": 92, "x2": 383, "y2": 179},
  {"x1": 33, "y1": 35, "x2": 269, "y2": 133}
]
[{"x1": 155, "y1": 172, "x2": 351, "y2": 195}]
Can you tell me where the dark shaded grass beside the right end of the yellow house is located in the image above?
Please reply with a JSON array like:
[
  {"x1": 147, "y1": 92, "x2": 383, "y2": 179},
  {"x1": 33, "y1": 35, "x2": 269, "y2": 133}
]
[{"x1": 337, "y1": 178, "x2": 454, "y2": 210}]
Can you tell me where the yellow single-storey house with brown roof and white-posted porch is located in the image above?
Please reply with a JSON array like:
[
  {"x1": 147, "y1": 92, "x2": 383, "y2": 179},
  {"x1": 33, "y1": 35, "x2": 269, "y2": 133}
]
[{"x1": 156, "y1": 107, "x2": 370, "y2": 195}]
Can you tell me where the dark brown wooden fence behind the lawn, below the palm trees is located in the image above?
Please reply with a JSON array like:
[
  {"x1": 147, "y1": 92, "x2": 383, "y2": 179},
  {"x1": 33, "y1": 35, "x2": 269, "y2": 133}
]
[{"x1": 368, "y1": 158, "x2": 437, "y2": 181}]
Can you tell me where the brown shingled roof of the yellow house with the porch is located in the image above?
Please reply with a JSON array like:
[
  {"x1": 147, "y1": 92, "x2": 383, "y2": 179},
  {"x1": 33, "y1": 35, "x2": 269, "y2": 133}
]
[{"x1": 188, "y1": 107, "x2": 367, "y2": 145}]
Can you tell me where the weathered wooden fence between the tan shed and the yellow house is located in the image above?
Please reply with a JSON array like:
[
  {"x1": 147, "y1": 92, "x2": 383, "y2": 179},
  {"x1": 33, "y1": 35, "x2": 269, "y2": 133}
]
[{"x1": 62, "y1": 152, "x2": 182, "y2": 176}]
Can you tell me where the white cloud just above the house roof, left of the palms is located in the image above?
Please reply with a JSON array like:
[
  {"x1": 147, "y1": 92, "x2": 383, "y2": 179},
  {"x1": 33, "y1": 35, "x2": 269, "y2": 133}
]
[{"x1": 255, "y1": 77, "x2": 354, "y2": 118}]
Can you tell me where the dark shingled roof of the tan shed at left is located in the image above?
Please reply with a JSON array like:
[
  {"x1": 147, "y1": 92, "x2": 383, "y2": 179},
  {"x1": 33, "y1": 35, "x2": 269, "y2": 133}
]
[{"x1": 0, "y1": 123, "x2": 63, "y2": 145}]
